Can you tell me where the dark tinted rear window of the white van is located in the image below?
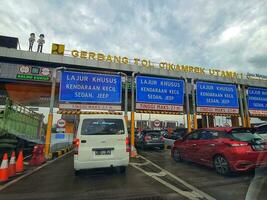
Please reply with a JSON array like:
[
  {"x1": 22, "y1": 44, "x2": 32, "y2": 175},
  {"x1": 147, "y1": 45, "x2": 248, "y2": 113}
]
[{"x1": 81, "y1": 119, "x2": 124, "y2": 135}]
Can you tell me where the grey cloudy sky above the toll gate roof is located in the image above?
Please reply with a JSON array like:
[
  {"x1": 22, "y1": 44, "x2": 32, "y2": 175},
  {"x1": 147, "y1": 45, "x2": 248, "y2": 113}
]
[{"x1": 0, "y1": 0, "x2": 267, "y2": 74}]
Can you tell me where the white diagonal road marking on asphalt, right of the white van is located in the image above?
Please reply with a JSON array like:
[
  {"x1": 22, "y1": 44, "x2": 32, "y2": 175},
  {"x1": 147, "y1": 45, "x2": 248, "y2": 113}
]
[{"x1": 130, "y1": 155, "x2": 215, "y2": 200}]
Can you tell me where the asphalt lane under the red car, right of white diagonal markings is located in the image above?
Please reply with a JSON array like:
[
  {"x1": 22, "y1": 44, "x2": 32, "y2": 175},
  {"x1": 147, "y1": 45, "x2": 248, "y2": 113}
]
[{"x1": 139, "y1": 150, "x2": 267, "y2": 200}]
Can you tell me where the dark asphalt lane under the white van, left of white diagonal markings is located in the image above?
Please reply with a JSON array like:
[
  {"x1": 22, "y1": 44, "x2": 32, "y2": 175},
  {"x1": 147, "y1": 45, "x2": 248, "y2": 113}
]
[{"x1": 0, "y1": 154, "x2": 185, "y2": 200}]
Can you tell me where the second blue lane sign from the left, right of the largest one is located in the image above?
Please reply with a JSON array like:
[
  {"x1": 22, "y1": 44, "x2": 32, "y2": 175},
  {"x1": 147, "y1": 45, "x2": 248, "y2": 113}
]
[{"x1": 136, "y1": 76, "x2": 184, "y2": 105}]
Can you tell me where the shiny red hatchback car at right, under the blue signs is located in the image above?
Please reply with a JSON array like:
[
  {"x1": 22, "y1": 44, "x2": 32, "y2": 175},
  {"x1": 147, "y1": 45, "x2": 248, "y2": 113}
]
[{"x1": 172, "y1": 127, "x2": 267, "y2": 175}]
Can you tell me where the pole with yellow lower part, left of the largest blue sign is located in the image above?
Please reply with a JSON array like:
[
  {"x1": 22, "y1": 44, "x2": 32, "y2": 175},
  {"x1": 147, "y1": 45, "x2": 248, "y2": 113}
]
[{"x1": 45, "y1": 67, "x2": 65, "y2": 158}]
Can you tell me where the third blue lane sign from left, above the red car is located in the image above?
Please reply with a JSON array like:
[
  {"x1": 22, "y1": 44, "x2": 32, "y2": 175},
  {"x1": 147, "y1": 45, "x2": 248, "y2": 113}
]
[{"x1": 196, "y1": 82, "x2": 238, "y2": 108}]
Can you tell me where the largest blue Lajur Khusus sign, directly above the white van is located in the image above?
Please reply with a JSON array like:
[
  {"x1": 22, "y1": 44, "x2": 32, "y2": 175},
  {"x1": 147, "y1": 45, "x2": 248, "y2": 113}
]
[{"x1": 59, "y1": 72, "x2": 122, "y2": 104}]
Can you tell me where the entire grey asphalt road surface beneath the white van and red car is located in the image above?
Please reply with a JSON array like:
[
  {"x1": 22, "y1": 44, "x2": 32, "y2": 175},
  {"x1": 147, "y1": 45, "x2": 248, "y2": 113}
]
[{"x1": 0, "y1": 150, "x2": 267, "y2": 200}]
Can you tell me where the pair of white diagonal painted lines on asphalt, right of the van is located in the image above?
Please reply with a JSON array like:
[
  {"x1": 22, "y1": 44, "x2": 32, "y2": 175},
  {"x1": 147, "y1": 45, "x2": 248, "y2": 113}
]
[{"x1": 131, "y1": 155, "x2": 215, "y2": 200}]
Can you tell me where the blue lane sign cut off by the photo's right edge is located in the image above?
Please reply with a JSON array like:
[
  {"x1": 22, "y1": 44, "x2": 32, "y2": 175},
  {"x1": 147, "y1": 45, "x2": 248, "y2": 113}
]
[{"x1": 248, "y1": 87, "x2": 267, "y2": 110}]
